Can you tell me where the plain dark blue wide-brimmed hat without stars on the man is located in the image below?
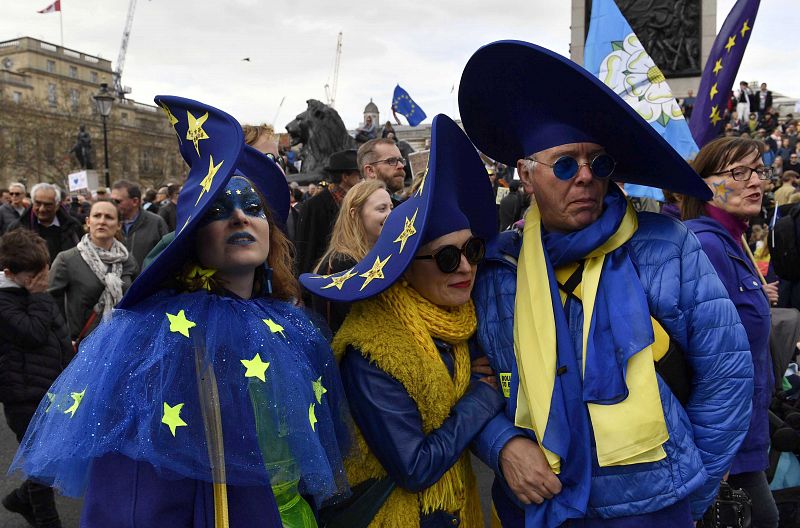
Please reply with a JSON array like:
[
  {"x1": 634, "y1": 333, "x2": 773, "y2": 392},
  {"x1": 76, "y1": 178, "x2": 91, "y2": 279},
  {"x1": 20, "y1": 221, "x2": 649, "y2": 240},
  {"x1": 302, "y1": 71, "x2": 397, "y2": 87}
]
[{"x1": 458, "y1": 40, "x2": 711, "y2": 200}]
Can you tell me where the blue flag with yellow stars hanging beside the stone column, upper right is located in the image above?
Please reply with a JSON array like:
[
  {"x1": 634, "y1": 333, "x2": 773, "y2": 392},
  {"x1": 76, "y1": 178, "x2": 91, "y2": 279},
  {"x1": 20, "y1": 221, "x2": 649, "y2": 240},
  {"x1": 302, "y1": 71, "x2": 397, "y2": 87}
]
[{"x1": 689, "y1": 0, "x2": 761, "y2": 148}]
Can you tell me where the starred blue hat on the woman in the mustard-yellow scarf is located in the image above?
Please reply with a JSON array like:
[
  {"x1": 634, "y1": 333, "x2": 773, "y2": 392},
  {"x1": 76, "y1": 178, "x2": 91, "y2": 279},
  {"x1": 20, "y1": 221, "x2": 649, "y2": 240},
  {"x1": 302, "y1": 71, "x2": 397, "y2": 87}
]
[{"x1": 300, "y1": 114, "x2": 497, "y2": 302}]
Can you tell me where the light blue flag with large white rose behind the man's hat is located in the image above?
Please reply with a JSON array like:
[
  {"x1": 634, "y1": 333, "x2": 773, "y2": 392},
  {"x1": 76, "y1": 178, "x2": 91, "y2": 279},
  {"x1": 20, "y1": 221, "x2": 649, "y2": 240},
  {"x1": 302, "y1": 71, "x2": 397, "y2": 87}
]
[{"x1": 584, "y1": 0, "x2": 699, "y2": 202}]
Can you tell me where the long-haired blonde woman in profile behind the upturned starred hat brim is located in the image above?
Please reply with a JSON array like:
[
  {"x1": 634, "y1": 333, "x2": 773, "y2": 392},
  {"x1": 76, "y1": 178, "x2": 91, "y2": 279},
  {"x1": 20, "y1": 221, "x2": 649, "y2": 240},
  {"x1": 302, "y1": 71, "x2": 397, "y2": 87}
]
[{"x1": 311, "y1": 180, "x2": 392, "y2": 333}]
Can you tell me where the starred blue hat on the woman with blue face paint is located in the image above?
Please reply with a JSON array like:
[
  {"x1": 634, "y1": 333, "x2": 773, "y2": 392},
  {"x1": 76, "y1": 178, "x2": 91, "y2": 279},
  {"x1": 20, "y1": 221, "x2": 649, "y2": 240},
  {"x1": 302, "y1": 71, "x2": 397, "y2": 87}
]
[{"x1": 117, "y1": 95, "x2": 289, "y2": 308}]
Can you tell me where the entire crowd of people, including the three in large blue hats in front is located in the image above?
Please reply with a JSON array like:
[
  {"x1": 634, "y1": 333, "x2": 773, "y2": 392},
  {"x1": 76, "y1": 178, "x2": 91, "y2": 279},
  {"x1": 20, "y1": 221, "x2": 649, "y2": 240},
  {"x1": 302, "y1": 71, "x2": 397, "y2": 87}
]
[{"x1": 0, "y1": 41, "x2": 800, "y2": 528}]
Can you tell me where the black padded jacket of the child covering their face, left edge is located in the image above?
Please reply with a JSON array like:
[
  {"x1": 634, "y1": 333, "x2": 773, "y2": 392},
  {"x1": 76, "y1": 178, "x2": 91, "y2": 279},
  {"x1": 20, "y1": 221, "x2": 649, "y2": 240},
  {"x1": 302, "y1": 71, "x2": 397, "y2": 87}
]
[{"x1": 0, "y1": 287, "x2": 73, "y2": 407}]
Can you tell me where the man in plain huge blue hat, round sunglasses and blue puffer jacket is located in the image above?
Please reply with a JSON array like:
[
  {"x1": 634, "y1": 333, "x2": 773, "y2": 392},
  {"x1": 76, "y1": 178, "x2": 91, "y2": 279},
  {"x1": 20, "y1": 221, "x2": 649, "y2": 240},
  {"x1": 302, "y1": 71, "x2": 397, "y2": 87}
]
[{"x1": 459, "y1": 41, "x2": 753, "y2": 528}]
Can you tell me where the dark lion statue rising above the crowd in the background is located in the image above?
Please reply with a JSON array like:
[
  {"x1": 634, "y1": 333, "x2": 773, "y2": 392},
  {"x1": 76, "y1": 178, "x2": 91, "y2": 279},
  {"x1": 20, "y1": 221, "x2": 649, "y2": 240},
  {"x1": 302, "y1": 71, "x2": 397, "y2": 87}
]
[{"x1": 286, "y1": 99, "x2": 358, "y2": 182}]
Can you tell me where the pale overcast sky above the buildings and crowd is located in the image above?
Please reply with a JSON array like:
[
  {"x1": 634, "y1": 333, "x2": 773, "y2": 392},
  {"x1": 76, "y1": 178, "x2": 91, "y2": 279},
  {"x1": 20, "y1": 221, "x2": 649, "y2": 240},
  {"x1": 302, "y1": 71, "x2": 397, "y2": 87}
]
[{"x1": 0, "y1": 0, "x2": 800, "y2": 131}]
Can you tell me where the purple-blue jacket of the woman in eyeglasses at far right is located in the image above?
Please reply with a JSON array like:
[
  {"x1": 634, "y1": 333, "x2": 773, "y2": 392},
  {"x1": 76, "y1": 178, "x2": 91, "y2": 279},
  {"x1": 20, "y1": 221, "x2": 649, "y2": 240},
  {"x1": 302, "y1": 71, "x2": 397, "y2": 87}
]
[{"x1": 686, "y1": 216, "x2": 775, "y2": 475}]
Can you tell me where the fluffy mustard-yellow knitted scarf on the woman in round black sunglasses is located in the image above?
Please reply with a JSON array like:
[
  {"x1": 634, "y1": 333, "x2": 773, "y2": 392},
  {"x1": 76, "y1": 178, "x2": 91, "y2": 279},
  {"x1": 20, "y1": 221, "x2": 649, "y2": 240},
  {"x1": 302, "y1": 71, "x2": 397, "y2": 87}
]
[{"x1": 333, "y1": 283, "x2": 482, "y2": 528}]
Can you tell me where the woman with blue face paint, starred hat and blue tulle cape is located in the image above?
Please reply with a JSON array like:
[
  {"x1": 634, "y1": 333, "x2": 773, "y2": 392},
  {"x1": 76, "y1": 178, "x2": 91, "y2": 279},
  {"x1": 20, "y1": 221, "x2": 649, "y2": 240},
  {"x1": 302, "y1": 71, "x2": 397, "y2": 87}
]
[{"x1": 11, "y1": 97, "x2": 346, "y2": 528}]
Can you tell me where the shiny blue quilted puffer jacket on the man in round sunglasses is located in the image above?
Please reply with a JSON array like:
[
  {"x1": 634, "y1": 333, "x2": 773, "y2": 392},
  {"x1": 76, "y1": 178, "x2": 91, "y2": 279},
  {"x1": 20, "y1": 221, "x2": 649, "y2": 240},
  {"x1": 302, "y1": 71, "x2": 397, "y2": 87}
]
[{"x1": 473, "y1": 213, "x2": 753, "y2": 519}]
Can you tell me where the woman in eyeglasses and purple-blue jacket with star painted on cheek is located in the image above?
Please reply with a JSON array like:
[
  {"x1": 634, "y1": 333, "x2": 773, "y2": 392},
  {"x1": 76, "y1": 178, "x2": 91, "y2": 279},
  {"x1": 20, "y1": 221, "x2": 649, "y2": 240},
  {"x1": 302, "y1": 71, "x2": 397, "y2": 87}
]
[{"x1": 682, "y1": 138, "x2": 778, "y2": 528}]
